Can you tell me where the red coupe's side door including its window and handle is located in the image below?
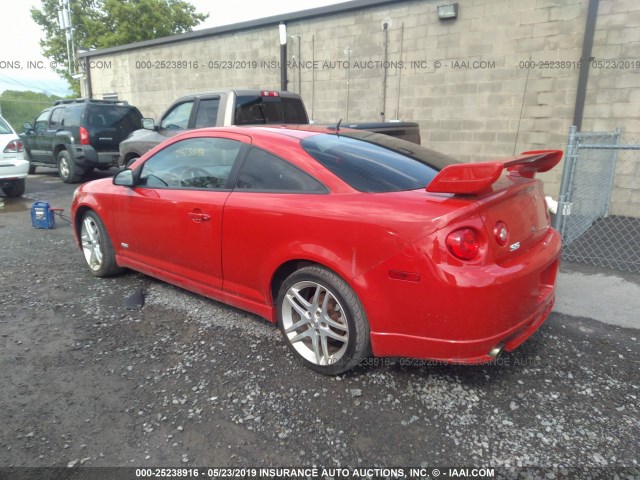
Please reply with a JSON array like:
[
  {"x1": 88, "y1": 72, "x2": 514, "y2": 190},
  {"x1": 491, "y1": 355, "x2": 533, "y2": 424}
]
[{"x1": 115, "y1": 134, "x2": 250, "y2": 290}]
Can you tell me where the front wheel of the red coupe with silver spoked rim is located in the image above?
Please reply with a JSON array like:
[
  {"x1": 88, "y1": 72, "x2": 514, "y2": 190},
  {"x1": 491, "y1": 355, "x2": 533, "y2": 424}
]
[{"x1": 80, "y1": 210, "x2": 124, "y2": 277}]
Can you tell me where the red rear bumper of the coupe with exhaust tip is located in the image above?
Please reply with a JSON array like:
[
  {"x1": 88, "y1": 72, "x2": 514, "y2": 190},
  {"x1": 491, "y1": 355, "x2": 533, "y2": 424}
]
[{"x1": 360, "y1": 229, "x2": 561, "y2": 364}]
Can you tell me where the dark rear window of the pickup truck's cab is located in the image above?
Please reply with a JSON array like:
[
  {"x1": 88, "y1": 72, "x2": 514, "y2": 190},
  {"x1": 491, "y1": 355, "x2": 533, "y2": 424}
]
[{"x1": 235, "y1": 95, "x2": 308, "y2": 125}]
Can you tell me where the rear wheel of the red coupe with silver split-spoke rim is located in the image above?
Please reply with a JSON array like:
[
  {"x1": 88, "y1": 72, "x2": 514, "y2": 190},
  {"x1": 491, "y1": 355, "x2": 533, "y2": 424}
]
[{"x1": 277, "y1": 266, "x2": 370, "y2": 375}]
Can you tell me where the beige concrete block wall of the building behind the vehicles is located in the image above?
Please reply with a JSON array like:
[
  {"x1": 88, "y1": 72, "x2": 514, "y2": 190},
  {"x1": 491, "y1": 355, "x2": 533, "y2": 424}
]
[{"x1": 81, "y1": 0, "x2": 640, "y2": 215}]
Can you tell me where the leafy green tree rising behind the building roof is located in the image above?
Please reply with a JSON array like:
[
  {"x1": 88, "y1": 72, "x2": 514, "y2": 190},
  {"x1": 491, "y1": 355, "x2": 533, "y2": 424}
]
[{"x1": 31, "y1": 0, "x2": 209, "y2": 95}]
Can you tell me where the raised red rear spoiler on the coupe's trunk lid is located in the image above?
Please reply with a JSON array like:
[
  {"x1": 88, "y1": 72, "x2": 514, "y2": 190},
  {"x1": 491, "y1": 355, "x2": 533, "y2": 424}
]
[{"x1": 427, "y1": 150, "x2": 562, "y2": 195}]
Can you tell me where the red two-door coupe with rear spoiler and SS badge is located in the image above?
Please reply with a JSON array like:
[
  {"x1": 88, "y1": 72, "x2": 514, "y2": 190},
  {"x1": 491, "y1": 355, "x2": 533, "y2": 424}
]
[{"x1": 72, "y1": 126, "x2": 562, "y2": 374}]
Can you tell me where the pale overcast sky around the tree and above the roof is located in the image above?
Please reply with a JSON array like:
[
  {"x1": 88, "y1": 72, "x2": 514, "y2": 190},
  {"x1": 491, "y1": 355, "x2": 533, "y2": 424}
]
[{"x1": 0, "y1": 0, "x2": 347, "y2": 95}]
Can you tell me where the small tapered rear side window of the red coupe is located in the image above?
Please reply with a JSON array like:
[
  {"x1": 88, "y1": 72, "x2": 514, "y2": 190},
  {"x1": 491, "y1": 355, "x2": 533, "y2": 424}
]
[{"x1": 236, "y1": 147, "x2": 327, "y2": 193}]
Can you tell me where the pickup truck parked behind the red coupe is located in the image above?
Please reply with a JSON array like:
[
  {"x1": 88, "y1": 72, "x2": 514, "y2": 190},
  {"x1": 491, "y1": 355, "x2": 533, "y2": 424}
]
[{"x1": 119, "y1": 90, "x2": 420, "y2": 166}]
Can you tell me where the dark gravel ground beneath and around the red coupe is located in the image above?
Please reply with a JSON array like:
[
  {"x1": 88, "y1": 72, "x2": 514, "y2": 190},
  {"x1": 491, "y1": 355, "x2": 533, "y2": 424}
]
[{"x1": 0, "y1": 169, "x2": 640, "y2": 478}]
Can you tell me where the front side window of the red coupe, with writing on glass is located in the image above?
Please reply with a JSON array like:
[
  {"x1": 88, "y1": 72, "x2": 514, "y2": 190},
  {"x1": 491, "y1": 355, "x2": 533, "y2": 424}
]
[{"x1": 138, "y1": 138, "x2": 243, "y2": 190}]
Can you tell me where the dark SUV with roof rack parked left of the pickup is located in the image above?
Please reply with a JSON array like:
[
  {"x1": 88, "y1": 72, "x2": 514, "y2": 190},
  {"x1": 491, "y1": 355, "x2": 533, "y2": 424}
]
[{"x1": 20, "y1": 99, "x2": 142, "y2": 183}]
